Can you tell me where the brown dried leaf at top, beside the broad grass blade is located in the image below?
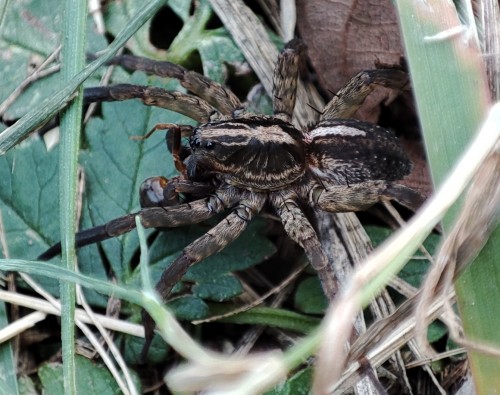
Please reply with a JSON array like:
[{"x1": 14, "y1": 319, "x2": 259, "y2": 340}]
[{"x1": 297, "y1": 0, "x2": 403, "y2": 92}]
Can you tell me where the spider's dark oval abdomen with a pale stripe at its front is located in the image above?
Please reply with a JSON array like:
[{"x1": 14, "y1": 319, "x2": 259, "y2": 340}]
[{"x1": 308, "y1": 119, "x2": 411, "y2": 184}]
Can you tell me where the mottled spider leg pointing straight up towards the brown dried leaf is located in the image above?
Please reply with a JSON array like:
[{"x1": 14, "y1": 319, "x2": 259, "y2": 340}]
[{"x1": 273, "y1": 40, "x2": 305, "y2": 122}]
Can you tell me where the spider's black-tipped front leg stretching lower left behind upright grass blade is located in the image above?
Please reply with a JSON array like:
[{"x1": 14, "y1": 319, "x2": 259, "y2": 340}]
[{"x1": 38, "y1": 184, "x2": 238, "y2": 261}]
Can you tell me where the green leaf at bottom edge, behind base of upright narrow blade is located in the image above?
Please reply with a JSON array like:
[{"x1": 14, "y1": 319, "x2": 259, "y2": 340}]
[{"x1": 38, "y1": 355, "x2": 121, "y2": 395}]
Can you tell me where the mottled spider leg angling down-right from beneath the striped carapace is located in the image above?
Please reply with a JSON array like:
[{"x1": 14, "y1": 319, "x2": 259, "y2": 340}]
[{"x1": 270, "y1": 193, "x2": 338, "y2": 300}]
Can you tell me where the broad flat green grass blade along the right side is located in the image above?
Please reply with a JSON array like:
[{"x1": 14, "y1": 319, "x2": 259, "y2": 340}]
[{"x1": 397, "y1": 0, "x2": 500, "y2": 393}]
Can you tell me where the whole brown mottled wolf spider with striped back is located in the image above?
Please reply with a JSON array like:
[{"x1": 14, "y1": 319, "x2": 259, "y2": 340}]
[{"x1": 40, "y1": 40, "x2": 421, "y2": 344}]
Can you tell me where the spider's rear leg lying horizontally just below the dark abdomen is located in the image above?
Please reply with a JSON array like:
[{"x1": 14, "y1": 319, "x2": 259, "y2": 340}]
[{"x1": 311, "y1": 180, "x2": 425, "y2": 213}]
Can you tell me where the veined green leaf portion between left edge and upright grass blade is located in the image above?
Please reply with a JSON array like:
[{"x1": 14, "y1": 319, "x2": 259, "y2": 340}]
[{"x1": 0, "y1": 138, "x2": 59, "y2": 258}]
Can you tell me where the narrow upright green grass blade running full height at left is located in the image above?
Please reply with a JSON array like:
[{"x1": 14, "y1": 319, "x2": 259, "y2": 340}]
[{"x1": 59, "y1": 0, "x2": 87, "y2": 394}]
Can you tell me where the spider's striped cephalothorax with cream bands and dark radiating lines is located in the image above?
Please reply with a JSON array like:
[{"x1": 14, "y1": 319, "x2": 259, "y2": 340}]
[{"x1": 187, "y1": 116, "x2": 305, "y2": 191}]
